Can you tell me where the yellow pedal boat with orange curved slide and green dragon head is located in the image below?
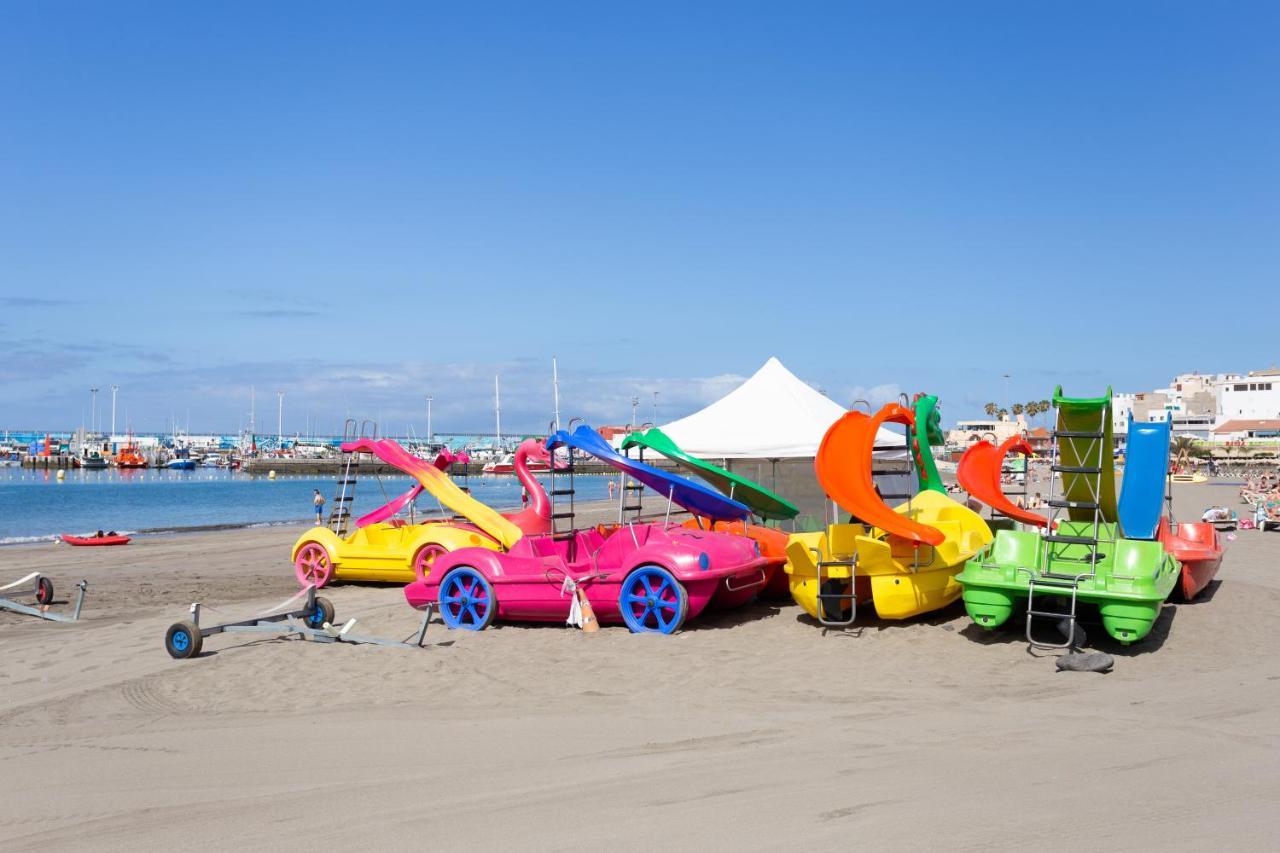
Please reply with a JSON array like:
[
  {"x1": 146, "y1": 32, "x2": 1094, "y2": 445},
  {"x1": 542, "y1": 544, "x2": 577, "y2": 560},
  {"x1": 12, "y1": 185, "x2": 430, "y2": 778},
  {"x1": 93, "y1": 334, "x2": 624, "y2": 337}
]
[{"x1": 786, "y1": 394, "x2": 992, "y2": 626}]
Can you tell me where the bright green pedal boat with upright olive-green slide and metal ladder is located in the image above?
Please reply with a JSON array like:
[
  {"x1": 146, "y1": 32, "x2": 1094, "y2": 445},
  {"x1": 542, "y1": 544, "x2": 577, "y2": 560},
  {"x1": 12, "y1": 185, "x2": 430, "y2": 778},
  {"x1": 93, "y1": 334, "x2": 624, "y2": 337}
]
[{"x1": 956, "y1": 387, "x2": 1180, "y2": 648}]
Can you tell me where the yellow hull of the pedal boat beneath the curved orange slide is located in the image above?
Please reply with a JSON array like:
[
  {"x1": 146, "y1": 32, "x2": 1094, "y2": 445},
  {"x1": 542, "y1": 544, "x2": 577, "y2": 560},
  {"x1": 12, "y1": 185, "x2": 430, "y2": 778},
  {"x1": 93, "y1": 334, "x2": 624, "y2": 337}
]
[{"x1": 785, "y1": 492, "x2": 992, "y2": 620}]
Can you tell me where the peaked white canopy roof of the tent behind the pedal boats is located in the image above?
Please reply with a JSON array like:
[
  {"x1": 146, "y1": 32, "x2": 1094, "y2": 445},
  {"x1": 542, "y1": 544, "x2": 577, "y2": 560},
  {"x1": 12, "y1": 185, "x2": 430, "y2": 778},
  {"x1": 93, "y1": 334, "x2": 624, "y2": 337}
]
[{"x1": 662, "y1": 357, "x2": 905, "y2": 459}]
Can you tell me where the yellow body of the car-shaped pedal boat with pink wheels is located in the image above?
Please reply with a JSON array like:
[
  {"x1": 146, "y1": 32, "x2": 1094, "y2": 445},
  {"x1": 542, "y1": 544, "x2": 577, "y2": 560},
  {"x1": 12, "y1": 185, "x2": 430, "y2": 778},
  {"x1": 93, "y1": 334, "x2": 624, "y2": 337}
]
[{"x1": 289, "y1": 523, "x2": 500, "y2": 584}]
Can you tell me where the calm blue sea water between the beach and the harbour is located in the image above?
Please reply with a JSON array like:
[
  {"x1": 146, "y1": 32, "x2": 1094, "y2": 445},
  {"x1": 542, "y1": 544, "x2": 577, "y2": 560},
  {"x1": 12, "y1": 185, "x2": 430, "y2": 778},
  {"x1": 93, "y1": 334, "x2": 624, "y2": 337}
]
[{"x1": 0, "y1": 466, "x2": 608, "y2": 544}]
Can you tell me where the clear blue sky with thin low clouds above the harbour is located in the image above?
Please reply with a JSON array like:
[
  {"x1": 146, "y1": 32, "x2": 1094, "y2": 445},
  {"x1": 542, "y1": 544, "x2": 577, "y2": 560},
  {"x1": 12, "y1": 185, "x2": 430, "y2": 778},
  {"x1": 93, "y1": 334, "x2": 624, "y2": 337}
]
[{"x1": 0, "y1": 0, "x2": 1280, "y2": 430}]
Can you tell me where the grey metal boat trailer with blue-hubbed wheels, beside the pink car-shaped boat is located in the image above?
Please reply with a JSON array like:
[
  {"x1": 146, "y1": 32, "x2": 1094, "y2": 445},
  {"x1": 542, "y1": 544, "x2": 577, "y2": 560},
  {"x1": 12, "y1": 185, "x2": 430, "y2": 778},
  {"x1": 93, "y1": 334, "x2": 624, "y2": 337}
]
[{"x1": 164, "y1": 584, "x2": 434, "y2": 660}]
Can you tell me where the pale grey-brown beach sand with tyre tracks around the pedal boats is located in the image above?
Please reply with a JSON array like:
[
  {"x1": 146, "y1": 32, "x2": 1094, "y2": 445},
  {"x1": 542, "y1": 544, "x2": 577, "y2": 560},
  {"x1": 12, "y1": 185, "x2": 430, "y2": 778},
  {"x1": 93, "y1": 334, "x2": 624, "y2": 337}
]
[{"x1": 0, "y1": 485, "x2": 1280, "y2": 850}]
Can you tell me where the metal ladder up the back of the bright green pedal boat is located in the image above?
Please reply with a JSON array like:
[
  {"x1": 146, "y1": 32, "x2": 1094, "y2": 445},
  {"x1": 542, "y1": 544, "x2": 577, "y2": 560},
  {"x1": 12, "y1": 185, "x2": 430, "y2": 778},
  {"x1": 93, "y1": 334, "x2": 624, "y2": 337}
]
[{"x1": 1025, "y1": 406, "x2": 1115, "y2": 649}]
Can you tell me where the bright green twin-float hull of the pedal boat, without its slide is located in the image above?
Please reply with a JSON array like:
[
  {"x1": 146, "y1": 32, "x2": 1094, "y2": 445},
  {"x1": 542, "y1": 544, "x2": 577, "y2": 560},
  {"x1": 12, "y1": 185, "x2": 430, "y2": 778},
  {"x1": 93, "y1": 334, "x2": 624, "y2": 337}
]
[{"x1": 956, "y1": 521, "x2": 1180, "y2": 646}]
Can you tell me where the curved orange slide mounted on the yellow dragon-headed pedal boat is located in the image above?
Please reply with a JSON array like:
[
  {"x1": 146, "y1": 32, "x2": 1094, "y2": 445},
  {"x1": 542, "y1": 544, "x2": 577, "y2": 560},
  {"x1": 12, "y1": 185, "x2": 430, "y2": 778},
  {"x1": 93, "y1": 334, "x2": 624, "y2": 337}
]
[{"x1": 814, "y1": 403, "x2": 945, "y2": 546}]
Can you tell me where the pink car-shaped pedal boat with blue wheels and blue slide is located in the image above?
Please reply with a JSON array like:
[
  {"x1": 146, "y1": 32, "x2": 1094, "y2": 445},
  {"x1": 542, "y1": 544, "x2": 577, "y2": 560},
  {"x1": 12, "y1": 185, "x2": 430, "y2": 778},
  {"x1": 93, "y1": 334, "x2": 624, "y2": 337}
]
[{"x1": 404, "y1": 425, "x2": 768, "y2": 634}]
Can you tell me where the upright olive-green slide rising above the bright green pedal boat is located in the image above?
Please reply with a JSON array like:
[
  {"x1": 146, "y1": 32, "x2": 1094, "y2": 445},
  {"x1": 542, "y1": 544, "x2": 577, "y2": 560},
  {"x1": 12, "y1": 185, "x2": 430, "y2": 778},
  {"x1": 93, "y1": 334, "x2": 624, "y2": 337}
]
[{"x1": 1053, "y1": 386, "x2": 1116, "y2": 524}]
